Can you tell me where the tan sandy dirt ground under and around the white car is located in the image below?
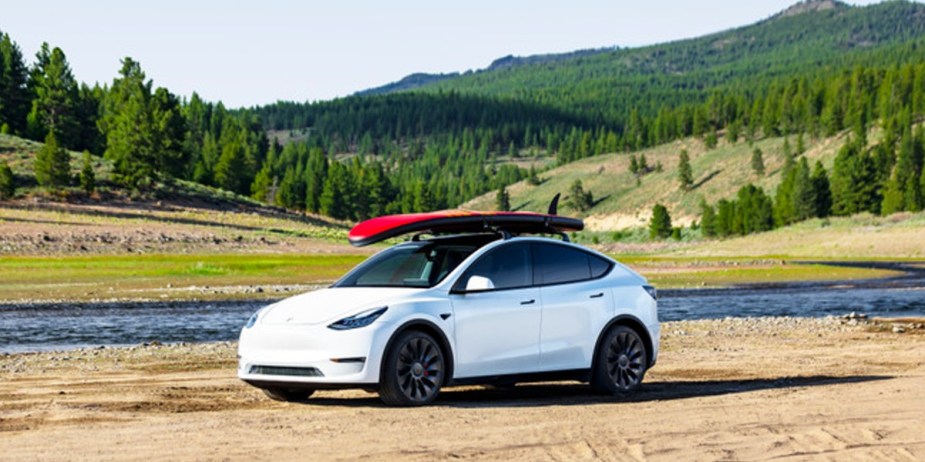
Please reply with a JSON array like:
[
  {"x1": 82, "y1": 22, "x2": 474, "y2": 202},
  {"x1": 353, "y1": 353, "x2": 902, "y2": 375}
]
[{"x1": 0, "y1": 318, "x2": 925, "y2": 461}]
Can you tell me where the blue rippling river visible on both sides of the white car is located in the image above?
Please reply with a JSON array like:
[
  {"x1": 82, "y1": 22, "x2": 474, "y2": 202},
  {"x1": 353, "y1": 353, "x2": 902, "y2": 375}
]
[{"x1": 0, "y1": 263, "x2": 925, "y2": 353}]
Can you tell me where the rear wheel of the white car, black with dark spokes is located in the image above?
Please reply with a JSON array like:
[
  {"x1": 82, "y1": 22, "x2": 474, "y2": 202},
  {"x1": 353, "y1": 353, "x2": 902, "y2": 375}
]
[{"x1": 591, "y1": 326, "x2": 649, "y2": 396}]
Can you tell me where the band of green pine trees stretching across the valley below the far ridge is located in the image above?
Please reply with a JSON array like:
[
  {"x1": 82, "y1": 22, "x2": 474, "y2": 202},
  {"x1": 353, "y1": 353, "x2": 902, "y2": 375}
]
[{"x1": 0, "y1": 20, "x2": 925, "y2": 225}]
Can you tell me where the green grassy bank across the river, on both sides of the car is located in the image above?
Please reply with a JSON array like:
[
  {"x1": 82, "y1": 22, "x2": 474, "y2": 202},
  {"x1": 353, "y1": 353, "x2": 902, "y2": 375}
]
[{"x1": 0, "y1": 254, "x2": 897, "y2": 301}]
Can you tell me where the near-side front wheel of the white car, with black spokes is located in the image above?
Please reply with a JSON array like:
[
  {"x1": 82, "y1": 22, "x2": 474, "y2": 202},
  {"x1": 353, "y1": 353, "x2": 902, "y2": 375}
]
[{"x1": 379, "y1": 330, "x2": 446, "y2": 406}]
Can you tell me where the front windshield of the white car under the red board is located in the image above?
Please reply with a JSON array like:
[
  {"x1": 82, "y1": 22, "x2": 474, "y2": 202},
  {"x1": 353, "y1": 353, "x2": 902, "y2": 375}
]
[{"x1": 334, "y1": 242, "x2": 479, "y2": 288}]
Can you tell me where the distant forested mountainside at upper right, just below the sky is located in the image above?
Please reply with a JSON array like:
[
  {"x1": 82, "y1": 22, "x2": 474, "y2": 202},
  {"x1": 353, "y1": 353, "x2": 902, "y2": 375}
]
[{"x1": 396, "y1": 0, "x2": 925, "y2": 122}]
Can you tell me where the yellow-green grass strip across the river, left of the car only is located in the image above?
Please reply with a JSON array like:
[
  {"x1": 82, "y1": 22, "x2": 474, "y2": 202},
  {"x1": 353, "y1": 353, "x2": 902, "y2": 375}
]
[{"x1": 0, "y1": 255, "x2": 366, "y2": 300}]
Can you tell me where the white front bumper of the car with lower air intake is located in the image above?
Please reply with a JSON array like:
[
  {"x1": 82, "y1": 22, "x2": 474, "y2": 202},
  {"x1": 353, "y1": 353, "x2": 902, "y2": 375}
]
[{"x1": 238, "y1": 323, "x2": 390, "y2": 388}]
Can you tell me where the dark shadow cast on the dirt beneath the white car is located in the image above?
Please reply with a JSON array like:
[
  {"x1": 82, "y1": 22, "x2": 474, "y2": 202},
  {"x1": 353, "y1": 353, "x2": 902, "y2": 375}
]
[{"x1": 305, "y1": 375, "x2": 893, "y2": 408}]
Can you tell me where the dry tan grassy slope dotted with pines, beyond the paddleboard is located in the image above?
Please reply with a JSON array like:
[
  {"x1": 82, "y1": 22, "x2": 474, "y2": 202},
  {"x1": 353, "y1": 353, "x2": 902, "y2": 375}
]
[{"x1": 462, "y1": 129, "x2": 846, "y2": 231}]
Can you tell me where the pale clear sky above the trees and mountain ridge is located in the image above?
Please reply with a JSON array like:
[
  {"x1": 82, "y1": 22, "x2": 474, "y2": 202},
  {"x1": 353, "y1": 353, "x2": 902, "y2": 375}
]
[{"x1": 0, "y1": 0, "x2": 877, "y2": 107}]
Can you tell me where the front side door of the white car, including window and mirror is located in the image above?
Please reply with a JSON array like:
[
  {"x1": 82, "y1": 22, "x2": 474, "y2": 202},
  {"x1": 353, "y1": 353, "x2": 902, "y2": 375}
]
[{"x1": 450, "y1": 242, "x2": 541, "y2": 378}]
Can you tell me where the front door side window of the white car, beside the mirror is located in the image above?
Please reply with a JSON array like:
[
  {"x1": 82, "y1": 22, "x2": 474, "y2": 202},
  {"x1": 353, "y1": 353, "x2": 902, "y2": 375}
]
[{"x1": 456, "y1": 244, "x2": 533, "y2": 290}]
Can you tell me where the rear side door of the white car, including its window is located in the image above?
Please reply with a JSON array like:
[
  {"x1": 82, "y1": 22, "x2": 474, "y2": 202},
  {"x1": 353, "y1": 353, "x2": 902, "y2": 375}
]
[{"x1": 533, "y1": 243, "x2": 613, "y2": 371}]
